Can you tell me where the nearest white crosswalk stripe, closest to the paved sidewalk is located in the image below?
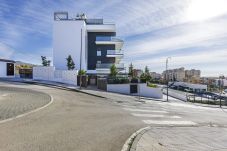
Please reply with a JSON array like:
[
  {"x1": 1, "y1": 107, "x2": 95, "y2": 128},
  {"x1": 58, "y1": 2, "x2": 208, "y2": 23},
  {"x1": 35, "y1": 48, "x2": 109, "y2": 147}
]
[{"x1": 143, "y1": 120, "x2": 196, "y2": 125}]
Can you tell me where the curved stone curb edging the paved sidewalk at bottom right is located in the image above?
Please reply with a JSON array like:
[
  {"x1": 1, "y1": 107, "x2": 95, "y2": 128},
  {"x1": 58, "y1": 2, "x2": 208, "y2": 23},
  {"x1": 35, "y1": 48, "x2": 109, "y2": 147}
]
[{"x1": 121, "y1": 126, "x2": 151, "y2": 151}]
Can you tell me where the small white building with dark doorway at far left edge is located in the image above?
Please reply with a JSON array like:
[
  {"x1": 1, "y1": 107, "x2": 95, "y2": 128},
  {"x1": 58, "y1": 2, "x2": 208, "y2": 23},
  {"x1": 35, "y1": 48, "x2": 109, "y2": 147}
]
[{"x1": 0, "y1": 59, "x2": 15, "y2": 78}]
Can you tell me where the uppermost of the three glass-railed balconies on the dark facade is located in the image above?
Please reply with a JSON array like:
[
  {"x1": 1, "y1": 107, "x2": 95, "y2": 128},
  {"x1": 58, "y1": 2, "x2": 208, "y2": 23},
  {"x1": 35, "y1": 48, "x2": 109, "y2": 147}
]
[{"x1": 95, "y1": 36, "x2": 124, "y2": 50}]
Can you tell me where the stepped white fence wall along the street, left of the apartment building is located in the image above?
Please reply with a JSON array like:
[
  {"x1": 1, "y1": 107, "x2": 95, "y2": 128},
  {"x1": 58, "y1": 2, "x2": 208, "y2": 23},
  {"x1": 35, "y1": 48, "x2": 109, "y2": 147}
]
[{"x1": 33, "y1": 66, "x2": 78, "y2": 85}]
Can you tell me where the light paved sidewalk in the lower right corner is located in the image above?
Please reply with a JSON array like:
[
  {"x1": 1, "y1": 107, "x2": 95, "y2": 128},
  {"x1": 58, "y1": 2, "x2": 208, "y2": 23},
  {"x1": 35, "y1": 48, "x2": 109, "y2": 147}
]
[{"x1": 131, "y1": 126, "x2": 227, "y2": 151}]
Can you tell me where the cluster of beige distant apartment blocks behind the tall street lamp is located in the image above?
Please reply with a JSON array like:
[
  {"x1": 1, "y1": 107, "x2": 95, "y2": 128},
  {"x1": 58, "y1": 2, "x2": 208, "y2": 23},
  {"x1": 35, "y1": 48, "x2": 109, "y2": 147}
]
[{"x1": 163, "y1": 67, "x2": 201, "y2": 83}]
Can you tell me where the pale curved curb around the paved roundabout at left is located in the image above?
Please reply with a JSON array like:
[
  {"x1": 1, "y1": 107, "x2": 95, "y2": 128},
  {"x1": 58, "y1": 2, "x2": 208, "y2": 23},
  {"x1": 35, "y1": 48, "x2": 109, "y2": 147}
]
[{"x1": 0, "y1": 94, "x2": 54, "y2": 124}]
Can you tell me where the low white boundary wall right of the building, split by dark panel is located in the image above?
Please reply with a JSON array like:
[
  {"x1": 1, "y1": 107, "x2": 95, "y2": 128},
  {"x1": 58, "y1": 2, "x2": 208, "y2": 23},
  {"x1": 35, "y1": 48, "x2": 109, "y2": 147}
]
[{"x1": 107, "y1": 84, "x2": 163, "y2": 99}]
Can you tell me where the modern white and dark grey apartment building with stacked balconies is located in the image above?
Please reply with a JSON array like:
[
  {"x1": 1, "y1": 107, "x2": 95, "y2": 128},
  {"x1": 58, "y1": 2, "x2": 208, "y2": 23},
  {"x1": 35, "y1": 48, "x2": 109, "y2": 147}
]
[{"x1": 53, "y1": 12, "x2": 124, "y2": 76}]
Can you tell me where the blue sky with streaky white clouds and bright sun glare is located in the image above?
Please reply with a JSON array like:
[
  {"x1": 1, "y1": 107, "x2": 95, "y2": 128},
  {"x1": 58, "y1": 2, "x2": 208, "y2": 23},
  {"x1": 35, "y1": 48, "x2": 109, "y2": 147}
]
[{"x1": 0, "y1": 0, "x2": 227, "y2": 76}]
